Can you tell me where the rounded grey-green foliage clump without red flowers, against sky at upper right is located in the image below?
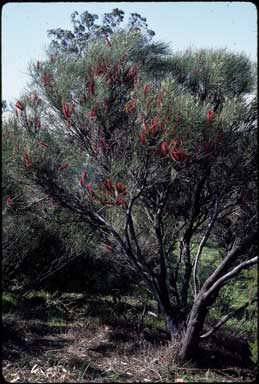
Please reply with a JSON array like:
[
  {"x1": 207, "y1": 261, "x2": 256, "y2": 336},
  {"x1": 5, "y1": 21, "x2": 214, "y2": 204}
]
[{"x1": 170, "y1": 49, "x2": 255, "y2": 101}]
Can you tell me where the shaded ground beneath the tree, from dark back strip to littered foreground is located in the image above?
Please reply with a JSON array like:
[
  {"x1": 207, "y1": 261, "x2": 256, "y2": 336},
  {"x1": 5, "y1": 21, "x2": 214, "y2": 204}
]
[{"x1": 2, "y1": 292, "x2": 256, "y2": 383}]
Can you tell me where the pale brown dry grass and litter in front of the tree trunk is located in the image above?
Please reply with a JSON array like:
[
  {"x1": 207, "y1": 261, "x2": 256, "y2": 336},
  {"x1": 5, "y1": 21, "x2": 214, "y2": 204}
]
[{"x1": 2, "y1": 292, "x2": 254, "y2": 383}]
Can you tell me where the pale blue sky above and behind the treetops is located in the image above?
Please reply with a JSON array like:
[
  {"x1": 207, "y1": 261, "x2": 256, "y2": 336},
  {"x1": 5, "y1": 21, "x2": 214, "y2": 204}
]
[{"x1": 2, "y1": 1, "x2": 257, "y2": 102}]
